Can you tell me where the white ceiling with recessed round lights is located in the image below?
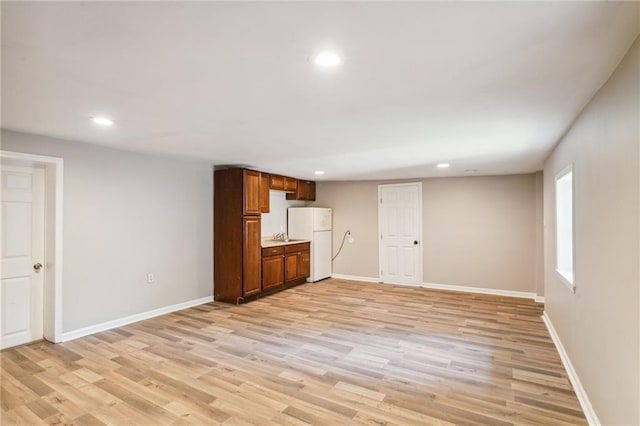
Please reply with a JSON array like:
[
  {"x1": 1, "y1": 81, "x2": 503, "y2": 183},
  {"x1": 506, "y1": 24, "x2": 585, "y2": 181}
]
[{"x1": 2, "y1": 2, "x2": 640, "y2": 180}]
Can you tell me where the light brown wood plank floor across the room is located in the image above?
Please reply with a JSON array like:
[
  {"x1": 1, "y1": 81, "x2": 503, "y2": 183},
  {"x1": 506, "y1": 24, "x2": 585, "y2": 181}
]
[{"x1": 0, "y1": 279, "x2": 586, "y2": 425}]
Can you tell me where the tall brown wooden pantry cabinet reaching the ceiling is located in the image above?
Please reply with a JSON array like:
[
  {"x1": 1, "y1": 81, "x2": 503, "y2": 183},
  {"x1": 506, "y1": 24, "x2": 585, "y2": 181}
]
[{"x1": 213, "y1": 169, "x2": 262, "y2": 303}]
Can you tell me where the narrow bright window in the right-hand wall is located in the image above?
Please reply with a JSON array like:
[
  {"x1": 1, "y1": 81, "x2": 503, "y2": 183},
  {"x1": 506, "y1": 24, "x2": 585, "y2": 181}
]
[{"x1": 556, "y1": 165, "x2": 575, "y2": 290}]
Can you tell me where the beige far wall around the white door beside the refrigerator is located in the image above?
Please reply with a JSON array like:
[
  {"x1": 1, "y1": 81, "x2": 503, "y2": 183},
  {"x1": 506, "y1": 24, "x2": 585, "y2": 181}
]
[{"x1": 316, "y1": 174, "x2": 542, "y2": 293}]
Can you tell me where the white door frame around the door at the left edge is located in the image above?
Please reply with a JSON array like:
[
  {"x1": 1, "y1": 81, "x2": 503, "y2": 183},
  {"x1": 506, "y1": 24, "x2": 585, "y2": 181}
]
[{"x1": 0, "y1": 151, "x2": 64, "y2": 343}]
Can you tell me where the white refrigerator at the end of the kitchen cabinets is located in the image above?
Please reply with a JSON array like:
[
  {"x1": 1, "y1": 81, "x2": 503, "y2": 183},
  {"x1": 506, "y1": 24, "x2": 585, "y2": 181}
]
[{"x1": 288, "y1": 207, "x2": 331, "y2": 282}]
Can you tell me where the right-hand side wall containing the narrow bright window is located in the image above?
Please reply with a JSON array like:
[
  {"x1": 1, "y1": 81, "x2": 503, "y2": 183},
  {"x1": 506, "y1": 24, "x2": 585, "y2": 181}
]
[{"x1": 544, "y1": 39, "x2": 640, "y2": 425}]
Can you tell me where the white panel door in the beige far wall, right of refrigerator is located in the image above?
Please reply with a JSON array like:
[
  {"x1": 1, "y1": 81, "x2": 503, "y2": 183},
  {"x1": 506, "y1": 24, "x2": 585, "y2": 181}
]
[{"x1": 378, "y1": 182, "x2": 422, "y2": 285}]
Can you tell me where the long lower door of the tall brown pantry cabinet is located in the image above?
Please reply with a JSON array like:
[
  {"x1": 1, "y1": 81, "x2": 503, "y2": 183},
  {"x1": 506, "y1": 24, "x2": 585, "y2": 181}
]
[{"x1": 242, "y1": 216, "x2": 262, "y2": 296}]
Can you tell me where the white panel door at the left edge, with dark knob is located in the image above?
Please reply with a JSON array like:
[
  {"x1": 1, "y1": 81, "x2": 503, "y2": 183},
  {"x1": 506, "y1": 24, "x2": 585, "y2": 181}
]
[{"x1": 0, "y1": 165, "x2": 44, "y2": 349}]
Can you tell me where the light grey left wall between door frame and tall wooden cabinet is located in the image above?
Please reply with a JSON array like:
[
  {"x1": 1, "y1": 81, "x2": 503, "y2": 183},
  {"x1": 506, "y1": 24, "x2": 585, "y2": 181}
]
[{"x1": 2, "y1": 130, "x2": 213, "y2": 332}]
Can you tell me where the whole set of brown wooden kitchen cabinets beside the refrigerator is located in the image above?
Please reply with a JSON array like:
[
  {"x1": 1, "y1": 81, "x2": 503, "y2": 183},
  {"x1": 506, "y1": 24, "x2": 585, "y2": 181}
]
[{"x1": 213, "y1": 168, "x2": 315, "y2": 303}]
